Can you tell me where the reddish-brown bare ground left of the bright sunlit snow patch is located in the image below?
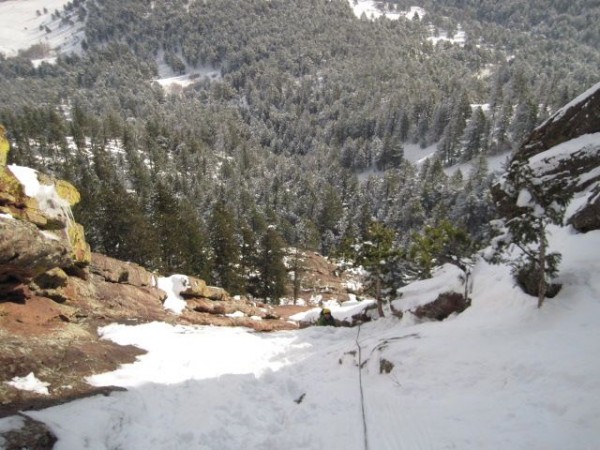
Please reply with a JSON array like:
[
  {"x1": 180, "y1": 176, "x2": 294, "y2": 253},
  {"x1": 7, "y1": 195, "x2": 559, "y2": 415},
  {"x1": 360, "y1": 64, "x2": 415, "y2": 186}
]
[{"x1": 0, "y1": 305, "x2": 144, "y2": 417}]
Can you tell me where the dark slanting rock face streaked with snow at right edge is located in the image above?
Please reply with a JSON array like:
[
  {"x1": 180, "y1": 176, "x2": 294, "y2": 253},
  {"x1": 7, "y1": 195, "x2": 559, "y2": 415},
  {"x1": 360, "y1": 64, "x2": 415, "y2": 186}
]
[{"x1": 492, "y1": 83, "x2": 600, "y2": 232}]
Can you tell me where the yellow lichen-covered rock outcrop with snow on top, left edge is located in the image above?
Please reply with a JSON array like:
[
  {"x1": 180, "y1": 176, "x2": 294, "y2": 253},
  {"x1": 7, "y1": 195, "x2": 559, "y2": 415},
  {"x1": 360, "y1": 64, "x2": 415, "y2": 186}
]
[{"x1": 0, "y1": 136, "x2": 91, "y2": 301}]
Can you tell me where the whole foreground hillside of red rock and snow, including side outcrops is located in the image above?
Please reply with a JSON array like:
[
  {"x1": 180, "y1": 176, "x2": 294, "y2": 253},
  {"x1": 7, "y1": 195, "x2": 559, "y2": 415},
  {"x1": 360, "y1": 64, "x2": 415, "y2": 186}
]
[{"x1": 0, "y1": 74, "x2": 600, "y2": 450}]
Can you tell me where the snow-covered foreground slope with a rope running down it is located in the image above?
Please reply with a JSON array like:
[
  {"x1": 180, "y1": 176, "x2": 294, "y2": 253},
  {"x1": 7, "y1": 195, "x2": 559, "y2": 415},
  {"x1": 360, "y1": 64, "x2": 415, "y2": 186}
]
[{"x1": 0, "y1": 218, "x2": 600, "y2": 450}]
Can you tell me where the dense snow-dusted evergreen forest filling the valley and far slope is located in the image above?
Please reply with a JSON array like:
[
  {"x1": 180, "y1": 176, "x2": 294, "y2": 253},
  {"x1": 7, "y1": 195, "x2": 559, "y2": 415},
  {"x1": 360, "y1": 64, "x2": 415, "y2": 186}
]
[{"x1": 0, "y1": 0, "x2": 600, "y2": 301}]
